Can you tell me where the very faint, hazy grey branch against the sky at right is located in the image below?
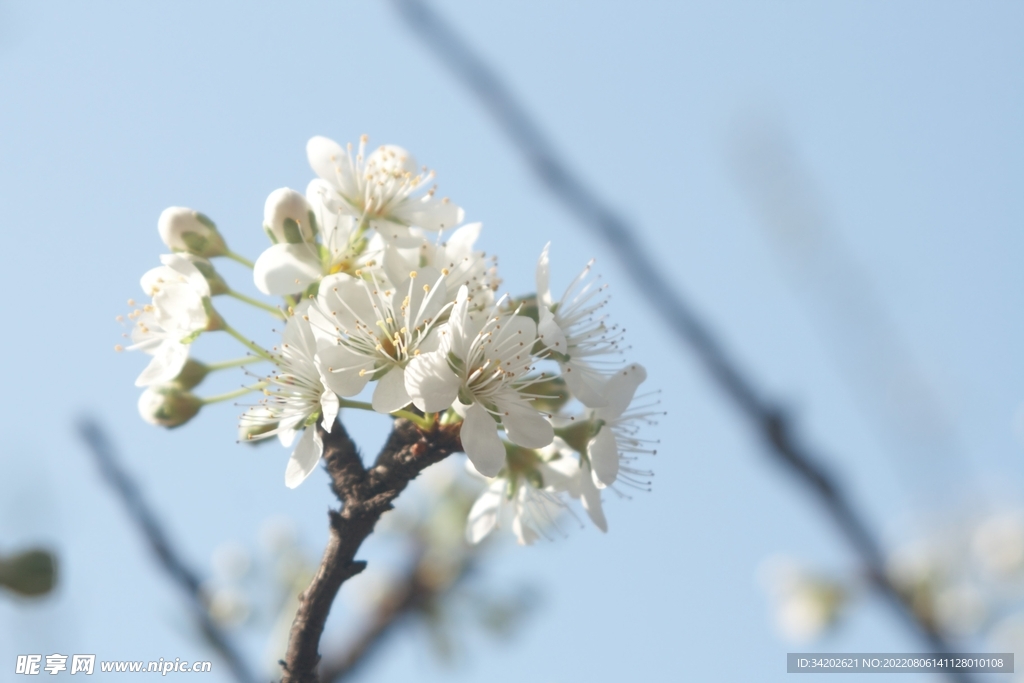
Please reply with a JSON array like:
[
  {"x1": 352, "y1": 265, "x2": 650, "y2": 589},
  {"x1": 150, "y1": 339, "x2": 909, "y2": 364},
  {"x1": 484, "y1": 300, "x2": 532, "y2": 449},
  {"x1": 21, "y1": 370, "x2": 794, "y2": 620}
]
[{"x1": 731, "y1": 120, "x2": 971, "y2": 511}]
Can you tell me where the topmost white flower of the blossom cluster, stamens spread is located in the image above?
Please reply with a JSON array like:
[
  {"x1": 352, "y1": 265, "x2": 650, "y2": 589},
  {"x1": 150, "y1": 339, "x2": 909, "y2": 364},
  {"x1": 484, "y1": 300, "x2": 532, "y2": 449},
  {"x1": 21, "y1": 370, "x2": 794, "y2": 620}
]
[{"x1": 306, "y1": 135, "x2": 463, "y2": 247}]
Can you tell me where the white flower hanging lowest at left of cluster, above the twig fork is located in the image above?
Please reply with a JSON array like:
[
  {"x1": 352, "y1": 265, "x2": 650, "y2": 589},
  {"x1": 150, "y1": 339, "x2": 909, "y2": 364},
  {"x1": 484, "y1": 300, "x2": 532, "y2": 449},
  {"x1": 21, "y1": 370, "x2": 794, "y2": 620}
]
[{"x1": 240, "y1": 307, "x2": 340, "y2": 488}]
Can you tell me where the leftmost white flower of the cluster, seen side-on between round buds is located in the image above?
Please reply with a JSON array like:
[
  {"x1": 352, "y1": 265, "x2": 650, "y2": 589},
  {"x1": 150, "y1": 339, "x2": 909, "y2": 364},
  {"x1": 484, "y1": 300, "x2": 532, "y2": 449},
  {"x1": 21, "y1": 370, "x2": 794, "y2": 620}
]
[{"x1": 128, "y1": 254, "x2": 210, "y2": 386}]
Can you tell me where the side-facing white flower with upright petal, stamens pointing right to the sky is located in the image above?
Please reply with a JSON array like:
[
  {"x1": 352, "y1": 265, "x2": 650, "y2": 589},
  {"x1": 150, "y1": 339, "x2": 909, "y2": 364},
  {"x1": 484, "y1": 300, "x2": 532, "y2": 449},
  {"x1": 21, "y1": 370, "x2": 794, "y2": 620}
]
[{"x1": 537, "y1": 243, "x2": 621, "y2": 408}]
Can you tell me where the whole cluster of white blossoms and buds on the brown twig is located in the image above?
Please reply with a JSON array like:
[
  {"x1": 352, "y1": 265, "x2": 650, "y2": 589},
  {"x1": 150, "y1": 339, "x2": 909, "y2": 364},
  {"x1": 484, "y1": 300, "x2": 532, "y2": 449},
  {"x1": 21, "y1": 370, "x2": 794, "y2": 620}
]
[{"x1": 119, "y1": 136, "x2": 658, "y2": 544}]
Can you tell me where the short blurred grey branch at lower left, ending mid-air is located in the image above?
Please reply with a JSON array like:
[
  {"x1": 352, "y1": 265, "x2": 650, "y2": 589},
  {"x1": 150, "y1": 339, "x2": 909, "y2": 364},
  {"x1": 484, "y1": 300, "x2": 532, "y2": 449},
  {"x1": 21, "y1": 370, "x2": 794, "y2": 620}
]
[{"x1": 78, "y1": 418, "x2": 258, "y2": 683}]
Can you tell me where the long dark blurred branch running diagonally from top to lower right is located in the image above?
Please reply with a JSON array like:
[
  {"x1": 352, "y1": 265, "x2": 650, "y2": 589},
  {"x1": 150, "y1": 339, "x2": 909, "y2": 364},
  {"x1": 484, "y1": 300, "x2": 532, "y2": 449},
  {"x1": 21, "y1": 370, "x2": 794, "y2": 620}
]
[{"x1": 392, "y1": 0, "x2": 969, "y2": 681}]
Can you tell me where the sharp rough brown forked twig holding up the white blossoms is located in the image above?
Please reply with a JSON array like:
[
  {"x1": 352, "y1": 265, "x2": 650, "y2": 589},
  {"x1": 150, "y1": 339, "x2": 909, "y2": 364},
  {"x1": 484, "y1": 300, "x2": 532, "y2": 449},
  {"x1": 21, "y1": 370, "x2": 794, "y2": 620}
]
[{"x1": 282, "y1": 420, "x2": 462, "y2": 683}]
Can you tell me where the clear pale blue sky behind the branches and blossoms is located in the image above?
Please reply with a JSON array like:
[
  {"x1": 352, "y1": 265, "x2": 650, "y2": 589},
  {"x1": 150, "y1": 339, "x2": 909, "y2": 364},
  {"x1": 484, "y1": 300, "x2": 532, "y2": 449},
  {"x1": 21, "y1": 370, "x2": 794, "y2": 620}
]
[{"x1": 0, "y1": 0, "x2": 1024, "y2": 683}]
